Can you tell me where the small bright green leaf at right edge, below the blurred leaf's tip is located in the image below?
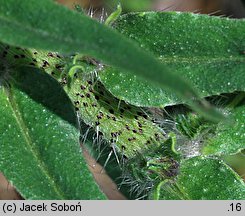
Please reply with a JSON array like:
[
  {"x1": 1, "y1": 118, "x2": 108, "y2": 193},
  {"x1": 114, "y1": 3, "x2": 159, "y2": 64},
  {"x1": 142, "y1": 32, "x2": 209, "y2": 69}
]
[{"x1": 203, "y1": 105, "x2": 245, "y2": 155}]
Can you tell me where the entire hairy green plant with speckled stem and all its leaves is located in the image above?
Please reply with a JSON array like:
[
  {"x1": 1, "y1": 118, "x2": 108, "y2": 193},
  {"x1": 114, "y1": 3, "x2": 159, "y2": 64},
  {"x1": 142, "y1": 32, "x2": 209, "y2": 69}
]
[{"x1": 0, "y1": 0, "x2": 245, "y2": 200}]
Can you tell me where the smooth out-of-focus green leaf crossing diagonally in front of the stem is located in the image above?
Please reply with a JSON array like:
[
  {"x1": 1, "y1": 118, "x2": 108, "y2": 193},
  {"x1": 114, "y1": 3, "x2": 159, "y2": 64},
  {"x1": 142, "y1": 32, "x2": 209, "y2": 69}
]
[{"x1": 0, "y1": 0, "x2": 221, "y2": 120}]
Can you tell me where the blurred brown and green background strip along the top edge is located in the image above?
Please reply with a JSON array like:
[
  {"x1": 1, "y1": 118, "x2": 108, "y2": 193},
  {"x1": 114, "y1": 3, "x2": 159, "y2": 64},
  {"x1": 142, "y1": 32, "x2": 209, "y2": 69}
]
[{"x1": 57, "y1": 0, "x2": 245, "y2": 18}]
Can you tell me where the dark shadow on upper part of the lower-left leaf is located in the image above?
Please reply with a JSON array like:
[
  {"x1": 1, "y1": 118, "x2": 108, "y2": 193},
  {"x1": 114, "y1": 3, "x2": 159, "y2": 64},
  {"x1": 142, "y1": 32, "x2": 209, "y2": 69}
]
[{"x1": 11, "y1": 66, "x2": 79, "y2": 128}]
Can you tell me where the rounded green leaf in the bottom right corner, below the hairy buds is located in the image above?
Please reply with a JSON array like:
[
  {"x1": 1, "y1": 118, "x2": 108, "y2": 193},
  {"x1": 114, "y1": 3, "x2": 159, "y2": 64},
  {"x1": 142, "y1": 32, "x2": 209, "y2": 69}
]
[{"x1": 158, "y1": 157, "x2": 245, "y2": 200}]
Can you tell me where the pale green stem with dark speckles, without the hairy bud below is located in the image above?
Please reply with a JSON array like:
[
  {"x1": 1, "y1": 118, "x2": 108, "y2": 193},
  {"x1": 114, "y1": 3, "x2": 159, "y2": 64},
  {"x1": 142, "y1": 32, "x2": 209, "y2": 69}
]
[{"x1": 0, "y1": 44, "x2": 166, "y2": 158}]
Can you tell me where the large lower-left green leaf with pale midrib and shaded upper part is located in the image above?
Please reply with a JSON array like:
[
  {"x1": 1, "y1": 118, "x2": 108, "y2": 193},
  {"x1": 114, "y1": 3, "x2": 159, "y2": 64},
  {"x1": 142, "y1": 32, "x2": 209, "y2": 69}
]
[{"x1": 0, "y1": 67, "x2": 105, "y2": 200}]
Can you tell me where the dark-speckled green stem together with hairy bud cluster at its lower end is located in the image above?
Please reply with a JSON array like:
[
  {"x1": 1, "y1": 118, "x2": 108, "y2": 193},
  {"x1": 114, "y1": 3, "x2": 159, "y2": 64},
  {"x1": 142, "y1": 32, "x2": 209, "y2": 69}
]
[{"x1": 1, "y1": 45, "x2": 178, "y2": 199}]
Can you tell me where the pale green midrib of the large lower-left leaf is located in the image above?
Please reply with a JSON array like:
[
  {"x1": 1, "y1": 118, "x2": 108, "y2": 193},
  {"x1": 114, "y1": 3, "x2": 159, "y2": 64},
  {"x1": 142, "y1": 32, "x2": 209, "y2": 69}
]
[{"x1": 4, "y1": 88, "x2": 65, "y2": 199}]
